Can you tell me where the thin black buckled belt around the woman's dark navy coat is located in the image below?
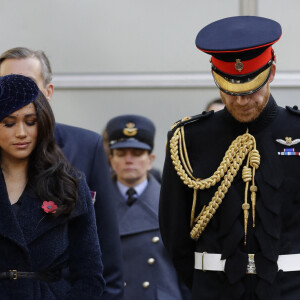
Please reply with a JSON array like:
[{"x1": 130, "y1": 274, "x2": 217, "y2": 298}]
[{"x1": 0, "y1": 270, "x2": 62, "y2": 281}]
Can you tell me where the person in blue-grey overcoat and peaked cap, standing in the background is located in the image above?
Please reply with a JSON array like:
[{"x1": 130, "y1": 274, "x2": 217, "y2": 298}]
[{"x1": 106, "y1": 115, "x2": 190, "y2": 300}]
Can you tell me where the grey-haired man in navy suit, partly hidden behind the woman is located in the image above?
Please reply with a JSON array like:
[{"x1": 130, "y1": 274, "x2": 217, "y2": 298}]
[{"x1": 0, "y1": 47, "x2": 123, "y2": 300}]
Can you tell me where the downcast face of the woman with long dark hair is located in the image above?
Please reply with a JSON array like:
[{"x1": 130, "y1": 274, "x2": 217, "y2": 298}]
[{"x1": 0, "y1": 103, "x2": 38, "y2": 162}]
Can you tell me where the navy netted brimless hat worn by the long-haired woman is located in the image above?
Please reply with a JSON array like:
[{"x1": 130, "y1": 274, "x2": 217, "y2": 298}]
[{"x1": 0, "y1": 74, "x2": 39, "y2": 121}]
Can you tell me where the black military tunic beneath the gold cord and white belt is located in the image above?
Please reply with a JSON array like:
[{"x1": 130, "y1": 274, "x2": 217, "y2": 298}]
[{"x1": 160, "y1": 96, "x2": 300, "y2": 300}]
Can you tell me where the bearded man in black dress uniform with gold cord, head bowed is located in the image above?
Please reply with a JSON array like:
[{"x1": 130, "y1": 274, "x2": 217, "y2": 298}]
[{"x1": 159, "y1": 16, "x2": 300, "y2": 300}]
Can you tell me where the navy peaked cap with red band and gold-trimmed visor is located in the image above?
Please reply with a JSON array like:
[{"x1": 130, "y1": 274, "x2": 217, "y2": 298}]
[{"x1": 196, "y1": 16, "x2": 282, "y2": 95}]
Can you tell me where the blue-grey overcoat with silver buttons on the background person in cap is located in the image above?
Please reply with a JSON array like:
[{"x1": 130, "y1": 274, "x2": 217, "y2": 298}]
[{"x1": 115, "y1": 175, "x2": 186, "y2": 300}]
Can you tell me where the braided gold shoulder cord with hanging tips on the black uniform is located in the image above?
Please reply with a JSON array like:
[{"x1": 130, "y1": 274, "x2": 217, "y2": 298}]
[{"x1": 170, "y1": 126, "x2": 260, "y2": 245}]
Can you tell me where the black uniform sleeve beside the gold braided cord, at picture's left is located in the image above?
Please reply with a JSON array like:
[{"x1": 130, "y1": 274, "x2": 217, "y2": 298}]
[{"x1": 159, "y1": 132, "x2": 195, "y2": 288}]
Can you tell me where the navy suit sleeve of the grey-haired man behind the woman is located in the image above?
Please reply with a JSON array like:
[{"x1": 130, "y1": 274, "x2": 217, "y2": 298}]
[{"x1": 88, "y1": 135, "x2": 124, "y2": 300}]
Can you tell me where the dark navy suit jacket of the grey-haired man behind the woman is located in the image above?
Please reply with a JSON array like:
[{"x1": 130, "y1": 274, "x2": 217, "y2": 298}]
[{"x1": 55, "y1": 124, "x2": 123, "y2": 300}]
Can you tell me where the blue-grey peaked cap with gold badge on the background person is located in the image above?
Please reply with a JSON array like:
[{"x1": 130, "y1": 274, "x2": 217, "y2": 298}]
[{"x1": 106, "y1": 115, "x2": 155, "y2": 151}]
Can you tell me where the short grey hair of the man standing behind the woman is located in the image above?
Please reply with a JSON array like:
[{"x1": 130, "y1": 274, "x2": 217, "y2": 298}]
[{"x1": 0, "y1": 47, "x2": 52, "y2": 87}]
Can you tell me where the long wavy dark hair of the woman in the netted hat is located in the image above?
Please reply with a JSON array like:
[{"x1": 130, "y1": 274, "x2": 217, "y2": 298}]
[{"x1": 28, "y1": 91, "x2": 80, "y2": 216}]
